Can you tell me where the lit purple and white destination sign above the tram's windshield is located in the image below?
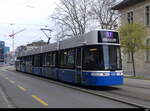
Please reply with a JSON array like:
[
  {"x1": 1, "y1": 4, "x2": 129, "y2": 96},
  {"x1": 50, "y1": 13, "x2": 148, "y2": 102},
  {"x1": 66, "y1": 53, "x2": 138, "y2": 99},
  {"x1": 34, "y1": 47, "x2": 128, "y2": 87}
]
[{"x1": 98, "y1": 31, "x2": 119, "y2": 43}]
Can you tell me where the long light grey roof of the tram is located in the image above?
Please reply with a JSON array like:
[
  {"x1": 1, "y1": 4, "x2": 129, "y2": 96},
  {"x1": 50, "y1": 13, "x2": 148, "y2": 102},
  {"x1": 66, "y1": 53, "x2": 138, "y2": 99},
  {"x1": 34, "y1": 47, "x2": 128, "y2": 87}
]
[{"x1": 18, "y1": 29, "x2": 116, "y2": 57}]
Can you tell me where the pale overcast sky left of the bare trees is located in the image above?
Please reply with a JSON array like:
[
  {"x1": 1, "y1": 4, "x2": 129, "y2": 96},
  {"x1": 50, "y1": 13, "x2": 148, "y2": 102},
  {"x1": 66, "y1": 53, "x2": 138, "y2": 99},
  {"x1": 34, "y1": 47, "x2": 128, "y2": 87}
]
[{"x1": 0, "y1": 0, "x2": 58, "y2": 50}]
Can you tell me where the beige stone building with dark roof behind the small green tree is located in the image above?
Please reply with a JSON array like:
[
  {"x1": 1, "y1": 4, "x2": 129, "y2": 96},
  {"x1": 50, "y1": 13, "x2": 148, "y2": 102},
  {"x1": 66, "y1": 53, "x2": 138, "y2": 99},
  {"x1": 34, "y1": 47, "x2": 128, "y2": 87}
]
[{"x1": 112, "y1": 0, "x2": 150, "y2": 78}]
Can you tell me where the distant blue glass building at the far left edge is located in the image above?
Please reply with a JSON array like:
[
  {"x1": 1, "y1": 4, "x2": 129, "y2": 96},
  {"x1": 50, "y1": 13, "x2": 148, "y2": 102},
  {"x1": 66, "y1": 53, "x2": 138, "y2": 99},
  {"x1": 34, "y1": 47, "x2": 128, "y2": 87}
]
[{"x1": 0, "y1": 41, "x2": 10, "y2": 64}]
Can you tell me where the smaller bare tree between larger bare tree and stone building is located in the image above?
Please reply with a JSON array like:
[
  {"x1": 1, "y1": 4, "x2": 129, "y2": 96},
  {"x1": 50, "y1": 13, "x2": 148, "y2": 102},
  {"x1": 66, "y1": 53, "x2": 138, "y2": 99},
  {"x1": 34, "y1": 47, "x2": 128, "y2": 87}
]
[{"x1": 91, "y1": 0, "x2": 118, "y2": 29}]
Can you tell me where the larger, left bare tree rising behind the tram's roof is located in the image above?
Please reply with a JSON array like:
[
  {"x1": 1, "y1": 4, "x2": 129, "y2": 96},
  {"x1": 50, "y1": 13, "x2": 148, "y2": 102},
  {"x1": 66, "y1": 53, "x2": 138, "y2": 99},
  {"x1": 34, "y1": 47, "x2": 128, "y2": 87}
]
[{"x1": 51, "y1": 0, "x2": 90, "y2": 37}]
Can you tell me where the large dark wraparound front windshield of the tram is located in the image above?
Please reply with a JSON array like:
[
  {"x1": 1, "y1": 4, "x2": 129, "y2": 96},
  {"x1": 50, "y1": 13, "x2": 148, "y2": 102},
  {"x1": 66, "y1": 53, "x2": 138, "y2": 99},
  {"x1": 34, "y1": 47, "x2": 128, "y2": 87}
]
[{"x1": 83, "y1": 45, "x2": 122, "y2": 71}]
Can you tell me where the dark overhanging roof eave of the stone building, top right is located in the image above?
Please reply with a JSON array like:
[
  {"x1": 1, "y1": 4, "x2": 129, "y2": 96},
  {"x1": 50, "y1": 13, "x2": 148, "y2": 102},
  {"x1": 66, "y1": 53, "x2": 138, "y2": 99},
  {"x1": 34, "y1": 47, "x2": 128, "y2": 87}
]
[{"x1": 111, "y1": 0, "x2": 144, "y2": 10}]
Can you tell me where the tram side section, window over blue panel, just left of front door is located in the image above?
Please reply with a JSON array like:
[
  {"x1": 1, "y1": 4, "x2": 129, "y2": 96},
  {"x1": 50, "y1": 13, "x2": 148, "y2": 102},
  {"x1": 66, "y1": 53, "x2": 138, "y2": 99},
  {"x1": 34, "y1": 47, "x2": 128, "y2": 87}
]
[{"x1": 57, "y1": 48, "x2": 76, "y2": 83}]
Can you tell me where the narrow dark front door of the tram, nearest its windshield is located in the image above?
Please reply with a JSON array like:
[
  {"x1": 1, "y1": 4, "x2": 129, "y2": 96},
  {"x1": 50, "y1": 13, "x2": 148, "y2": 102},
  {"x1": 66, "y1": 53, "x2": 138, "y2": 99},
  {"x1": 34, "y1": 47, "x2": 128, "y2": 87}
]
[{"x1": 76, "y1": 48, "x2": 82, "y2": 84}]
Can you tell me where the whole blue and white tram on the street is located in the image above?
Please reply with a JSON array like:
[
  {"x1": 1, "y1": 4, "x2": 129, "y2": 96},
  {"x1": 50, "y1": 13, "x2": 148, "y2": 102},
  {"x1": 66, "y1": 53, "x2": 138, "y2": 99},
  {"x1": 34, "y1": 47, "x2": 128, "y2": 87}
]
[{"x1": 16, "y1": 30, "x2": 123, "y2": 86}]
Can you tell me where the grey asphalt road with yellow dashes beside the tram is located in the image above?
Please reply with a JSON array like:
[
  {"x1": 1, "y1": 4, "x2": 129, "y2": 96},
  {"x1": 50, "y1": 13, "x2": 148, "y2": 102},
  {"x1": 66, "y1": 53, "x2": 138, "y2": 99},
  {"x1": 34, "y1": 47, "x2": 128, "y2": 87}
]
[{"x1": 0, "y1": 68, "x2": 134, "y2": 108}]
